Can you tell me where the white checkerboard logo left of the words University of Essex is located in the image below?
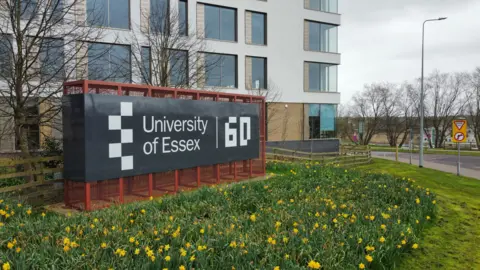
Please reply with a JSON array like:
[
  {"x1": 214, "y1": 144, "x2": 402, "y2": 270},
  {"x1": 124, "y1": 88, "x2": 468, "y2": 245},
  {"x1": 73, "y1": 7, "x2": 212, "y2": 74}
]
[{"x1": 108, "y1": 102, "x2": 133, "y2": 171}]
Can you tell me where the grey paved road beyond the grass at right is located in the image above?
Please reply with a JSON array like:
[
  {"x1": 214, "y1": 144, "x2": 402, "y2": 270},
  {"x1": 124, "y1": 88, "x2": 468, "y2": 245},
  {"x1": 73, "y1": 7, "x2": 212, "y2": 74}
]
[{"x1": 372, "y1": 152, "x2": 480, "y2": 180}]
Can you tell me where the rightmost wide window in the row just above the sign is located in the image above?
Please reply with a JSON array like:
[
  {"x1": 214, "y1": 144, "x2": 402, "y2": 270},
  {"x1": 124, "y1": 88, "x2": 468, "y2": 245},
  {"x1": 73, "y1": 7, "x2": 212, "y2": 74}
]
[{"x1": 205, "y1": 53, "x2": 237, "y2": 88}]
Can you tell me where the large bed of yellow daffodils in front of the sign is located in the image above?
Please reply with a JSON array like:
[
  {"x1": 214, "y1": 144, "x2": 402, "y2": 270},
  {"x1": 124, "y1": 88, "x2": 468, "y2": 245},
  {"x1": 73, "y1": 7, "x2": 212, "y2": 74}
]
[{"x1": 0, "y1": 163, "x2": 436, "y2": 270}]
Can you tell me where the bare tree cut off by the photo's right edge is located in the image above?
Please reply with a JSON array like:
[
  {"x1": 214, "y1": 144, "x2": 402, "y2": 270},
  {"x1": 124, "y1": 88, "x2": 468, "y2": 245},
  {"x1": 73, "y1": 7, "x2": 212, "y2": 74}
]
[{"x1": 465, "y1": 67, "x2": 480, "y2": 150}]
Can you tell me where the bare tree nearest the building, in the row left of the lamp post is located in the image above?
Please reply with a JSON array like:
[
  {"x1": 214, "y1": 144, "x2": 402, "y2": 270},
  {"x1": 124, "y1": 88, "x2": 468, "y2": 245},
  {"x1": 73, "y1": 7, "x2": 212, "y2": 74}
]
[{"x1": 352, "y1": 83, "x2": 384, "y2": 145}]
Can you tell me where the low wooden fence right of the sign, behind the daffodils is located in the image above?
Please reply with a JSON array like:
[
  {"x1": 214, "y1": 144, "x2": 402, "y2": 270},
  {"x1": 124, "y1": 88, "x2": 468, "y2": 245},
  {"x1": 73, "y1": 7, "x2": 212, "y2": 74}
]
[{"x1": 266, "y1": 146, "x2": 372, "y2": 167}]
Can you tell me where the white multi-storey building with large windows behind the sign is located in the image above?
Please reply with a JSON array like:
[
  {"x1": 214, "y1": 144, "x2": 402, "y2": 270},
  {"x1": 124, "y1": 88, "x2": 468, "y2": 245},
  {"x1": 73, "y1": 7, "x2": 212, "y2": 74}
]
[{"x1": 2, "y1": 0, "x2": 340, "y2": 152}]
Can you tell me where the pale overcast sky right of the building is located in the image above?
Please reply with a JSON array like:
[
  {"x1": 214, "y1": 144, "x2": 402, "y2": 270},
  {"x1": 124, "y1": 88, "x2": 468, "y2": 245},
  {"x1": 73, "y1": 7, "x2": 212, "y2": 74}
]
[{"x1": 338, "y1": 0, "x2": 480, "y2": 103}]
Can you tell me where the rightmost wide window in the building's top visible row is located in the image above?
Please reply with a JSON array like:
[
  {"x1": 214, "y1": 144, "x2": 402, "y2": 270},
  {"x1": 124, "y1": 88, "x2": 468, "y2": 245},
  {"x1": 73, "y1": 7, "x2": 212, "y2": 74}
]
[{"x1": 205, "y1": 5, "x2": 237, "y2": 41}]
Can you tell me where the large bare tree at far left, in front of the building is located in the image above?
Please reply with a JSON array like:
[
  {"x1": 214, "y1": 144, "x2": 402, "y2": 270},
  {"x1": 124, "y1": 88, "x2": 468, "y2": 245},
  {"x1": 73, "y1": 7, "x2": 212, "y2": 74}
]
[{"x1": 0, "y1": 0, "x2": 106, "y2": 179}]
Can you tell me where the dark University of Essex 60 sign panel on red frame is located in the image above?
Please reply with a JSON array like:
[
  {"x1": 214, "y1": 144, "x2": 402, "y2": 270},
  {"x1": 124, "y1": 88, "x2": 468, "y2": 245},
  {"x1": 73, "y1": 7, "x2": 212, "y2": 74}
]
[{"x1": 63, "y1": 94, "x2": 260, "y2": 182}]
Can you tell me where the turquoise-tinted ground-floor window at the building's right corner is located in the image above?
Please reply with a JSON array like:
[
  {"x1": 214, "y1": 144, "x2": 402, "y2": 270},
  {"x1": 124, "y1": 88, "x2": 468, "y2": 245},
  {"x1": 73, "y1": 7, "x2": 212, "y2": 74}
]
[{"x1": 305, "y1": 104, "x2": 337, "y2": 139}]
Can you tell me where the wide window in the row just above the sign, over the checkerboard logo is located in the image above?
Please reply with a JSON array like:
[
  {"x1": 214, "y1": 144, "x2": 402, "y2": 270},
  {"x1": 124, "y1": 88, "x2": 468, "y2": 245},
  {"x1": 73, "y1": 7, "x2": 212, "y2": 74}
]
[{"x1": 88, "y1": 43, "x2": 132, "y2": 83}]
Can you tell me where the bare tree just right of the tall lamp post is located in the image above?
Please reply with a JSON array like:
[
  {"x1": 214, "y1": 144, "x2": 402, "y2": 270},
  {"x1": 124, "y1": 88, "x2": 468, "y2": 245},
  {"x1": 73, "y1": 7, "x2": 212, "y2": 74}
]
[{"x1": 425, "y1": 71, "x2": 468, "y2": 148}]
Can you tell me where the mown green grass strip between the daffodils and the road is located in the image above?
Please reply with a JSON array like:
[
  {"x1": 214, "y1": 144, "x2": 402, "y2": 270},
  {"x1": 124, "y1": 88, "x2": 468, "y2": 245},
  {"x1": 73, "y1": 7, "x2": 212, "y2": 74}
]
[{"x1": 358, "y1": 159, "x2": 480, "y2": 269}]
